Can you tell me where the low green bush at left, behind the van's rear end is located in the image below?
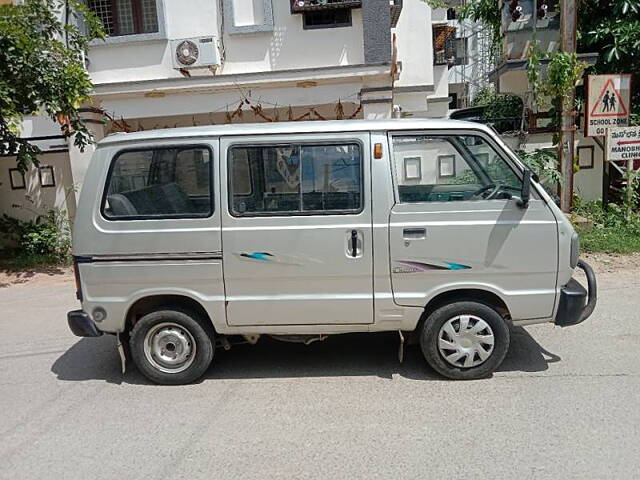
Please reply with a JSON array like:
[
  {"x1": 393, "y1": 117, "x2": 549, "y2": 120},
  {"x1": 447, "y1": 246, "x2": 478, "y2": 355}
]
[{"x1": 0, "y1": 210, "x2": 71, "y2": 264}]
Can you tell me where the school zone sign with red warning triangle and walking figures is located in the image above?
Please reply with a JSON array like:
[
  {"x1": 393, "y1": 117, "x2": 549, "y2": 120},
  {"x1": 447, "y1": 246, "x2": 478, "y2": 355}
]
[{"x1": 584, "y1": 73, "x2": 631, "y2": 137}]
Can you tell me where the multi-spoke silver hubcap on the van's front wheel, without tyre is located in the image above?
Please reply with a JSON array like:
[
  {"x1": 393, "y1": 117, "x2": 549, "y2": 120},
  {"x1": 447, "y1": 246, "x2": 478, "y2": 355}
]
[{"x1": 438, "y1": 315, "x2": 495, "y2": 368}]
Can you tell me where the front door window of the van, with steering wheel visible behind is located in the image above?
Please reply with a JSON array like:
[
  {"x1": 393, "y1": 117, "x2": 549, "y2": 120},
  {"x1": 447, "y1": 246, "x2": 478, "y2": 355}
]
[{"x1": 393, "y1": 135, "x2": 522, "y2": 203}]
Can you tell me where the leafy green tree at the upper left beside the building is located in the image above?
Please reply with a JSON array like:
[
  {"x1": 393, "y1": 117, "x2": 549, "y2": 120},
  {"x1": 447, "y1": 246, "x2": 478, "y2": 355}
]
[{"x1": 0, "y1": 0, "x2": 104, "y2": 170}]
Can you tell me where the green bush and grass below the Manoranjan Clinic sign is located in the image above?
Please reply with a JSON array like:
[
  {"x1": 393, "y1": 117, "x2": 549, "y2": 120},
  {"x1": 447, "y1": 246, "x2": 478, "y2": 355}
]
[{"x1": 573, "y1": 201, "x2": 640, "y2": 253}]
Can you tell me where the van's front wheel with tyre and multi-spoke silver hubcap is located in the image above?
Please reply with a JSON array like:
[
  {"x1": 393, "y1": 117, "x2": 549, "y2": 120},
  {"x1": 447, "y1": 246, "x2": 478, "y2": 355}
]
[{"x1": 420, "y1": 302, "x2": 510, "y2": 380}]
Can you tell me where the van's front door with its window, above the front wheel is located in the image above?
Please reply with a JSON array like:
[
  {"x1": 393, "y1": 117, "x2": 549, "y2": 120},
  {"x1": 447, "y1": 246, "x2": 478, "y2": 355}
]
[{"x1": 389, "y1": 131, "x2": 558, "y2": 320}]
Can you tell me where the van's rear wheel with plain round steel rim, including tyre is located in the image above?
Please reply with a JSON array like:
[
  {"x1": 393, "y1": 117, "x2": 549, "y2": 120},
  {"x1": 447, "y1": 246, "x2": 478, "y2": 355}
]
[{"x1": 129, "y1": 310, "x2": 214, "y2": 385}]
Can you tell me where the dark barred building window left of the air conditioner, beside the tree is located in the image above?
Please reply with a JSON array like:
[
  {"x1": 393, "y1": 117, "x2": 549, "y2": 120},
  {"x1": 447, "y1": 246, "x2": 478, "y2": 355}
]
[{"x1": 89, "y1": 0, "x2": 158, "y2": 37}]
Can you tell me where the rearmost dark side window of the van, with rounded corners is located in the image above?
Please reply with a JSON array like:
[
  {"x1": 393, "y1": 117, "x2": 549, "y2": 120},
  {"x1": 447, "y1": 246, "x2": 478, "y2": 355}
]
[{"x1": 102, "y1": 147, "x2": 213, "y2": 220}]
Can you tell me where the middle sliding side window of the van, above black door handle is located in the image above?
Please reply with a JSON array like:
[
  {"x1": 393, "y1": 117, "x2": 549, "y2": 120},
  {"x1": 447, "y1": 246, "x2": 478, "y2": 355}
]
[{"x1": 228, "y1": 143, "x2": 363, "y2": 216}]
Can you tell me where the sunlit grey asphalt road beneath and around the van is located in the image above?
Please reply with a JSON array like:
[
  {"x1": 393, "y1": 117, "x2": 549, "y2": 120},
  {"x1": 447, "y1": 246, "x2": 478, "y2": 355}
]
[{"x1": 0, "y1": 270, "x2": 640, "y2": 480}]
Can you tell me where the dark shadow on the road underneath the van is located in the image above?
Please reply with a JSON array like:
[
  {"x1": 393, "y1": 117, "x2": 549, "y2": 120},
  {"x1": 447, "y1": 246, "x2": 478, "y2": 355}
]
[{"x1": 51, "y1": 328, "x2": 561, "y2": 384}]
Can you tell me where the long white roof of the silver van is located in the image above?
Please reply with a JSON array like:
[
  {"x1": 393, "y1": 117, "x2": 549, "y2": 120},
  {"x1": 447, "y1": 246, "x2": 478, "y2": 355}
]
[{"x1": 99, "y1": 119, "x2": 489, "y2": 145}]
